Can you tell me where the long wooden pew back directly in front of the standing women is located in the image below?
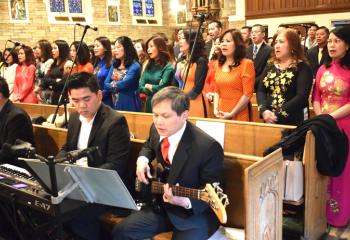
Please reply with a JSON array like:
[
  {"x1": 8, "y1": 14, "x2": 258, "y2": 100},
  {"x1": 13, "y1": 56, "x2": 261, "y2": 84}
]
[{"x1": 16, "y1": 103, "x2": 293, "y2": 156}]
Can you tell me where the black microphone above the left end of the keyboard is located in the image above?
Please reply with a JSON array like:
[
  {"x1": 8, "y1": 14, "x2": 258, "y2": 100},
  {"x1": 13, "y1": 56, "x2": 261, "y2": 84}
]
[{"x1": 2, "y1": 139, "x2": 35, "y2": 158}]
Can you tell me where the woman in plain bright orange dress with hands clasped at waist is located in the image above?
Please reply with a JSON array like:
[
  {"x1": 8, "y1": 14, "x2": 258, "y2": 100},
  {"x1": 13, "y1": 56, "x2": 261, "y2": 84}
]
[{"x1": 214, "y1": 29, "x2": 255, "y2": 121}]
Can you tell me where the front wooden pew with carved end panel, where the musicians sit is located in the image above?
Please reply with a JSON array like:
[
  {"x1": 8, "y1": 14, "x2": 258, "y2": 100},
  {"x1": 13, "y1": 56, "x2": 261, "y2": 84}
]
[{"x1": 30, "y1": 125, "x2": 283, "y2": 239}]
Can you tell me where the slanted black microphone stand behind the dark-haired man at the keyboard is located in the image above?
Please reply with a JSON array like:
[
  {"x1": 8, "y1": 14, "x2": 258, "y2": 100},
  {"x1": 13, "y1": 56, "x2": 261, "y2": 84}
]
[{"x1": 51, "y1": 26, "x2": 88, "y2": 126}]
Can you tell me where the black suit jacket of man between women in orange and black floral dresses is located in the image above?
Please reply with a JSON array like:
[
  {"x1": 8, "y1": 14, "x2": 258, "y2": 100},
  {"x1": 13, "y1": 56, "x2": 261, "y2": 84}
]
[{"x1": 247, "y1": 42, "x2": 272, "y2": 91}]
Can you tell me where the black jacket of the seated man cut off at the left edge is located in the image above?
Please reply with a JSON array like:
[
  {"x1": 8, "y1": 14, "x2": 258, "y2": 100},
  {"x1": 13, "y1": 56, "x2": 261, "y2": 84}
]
[{"x1": 0, "y1": 100, "x2": 34, "y2": 165}]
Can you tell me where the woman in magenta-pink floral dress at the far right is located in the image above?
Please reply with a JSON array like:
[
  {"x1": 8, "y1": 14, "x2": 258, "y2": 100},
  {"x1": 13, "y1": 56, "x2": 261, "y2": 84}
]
[{"x1": 313, "y1": 27, "x2": 350, "y2": 227}]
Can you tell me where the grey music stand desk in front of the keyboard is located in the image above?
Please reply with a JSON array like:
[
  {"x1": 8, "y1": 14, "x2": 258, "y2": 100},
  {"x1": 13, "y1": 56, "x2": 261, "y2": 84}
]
[{"x1": 21, "y1": 159, "x2": 137, "y2": 210}]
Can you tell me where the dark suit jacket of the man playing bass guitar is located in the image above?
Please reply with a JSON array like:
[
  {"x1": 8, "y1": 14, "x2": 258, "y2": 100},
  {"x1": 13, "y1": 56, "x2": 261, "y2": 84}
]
[{"x1": 140, "y1": 122, "x2": 223, "y2": 230}]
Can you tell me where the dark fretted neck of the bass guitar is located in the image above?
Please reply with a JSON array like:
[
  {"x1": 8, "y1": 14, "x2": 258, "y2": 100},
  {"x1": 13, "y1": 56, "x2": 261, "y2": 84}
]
[{"x1": 151, "y1": 181, "x2": 202, "y2": 200}]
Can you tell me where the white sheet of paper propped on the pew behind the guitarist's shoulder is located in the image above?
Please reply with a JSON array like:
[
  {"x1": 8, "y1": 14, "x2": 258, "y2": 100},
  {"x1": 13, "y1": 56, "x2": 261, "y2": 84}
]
[{"x1": 196, "y1": 120, "x2": 225, "y2": 148}]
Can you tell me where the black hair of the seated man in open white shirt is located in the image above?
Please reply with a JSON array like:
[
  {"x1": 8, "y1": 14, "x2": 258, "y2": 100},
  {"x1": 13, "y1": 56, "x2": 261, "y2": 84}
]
[{"x1": 67, "y1": 72, "x2": 100, "y2": 93}]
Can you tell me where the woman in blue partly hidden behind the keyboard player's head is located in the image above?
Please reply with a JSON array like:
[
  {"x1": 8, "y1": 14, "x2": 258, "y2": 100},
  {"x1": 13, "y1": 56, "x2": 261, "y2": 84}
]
[{"x1": 94, "y1": 37, "x2": 112, "y2": 107}]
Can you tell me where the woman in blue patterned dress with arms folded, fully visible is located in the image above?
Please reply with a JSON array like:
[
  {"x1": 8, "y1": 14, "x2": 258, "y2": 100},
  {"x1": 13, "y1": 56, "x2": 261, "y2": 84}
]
[{"x1": 104, "y1": 36, "x2": 141, "y2": 112}]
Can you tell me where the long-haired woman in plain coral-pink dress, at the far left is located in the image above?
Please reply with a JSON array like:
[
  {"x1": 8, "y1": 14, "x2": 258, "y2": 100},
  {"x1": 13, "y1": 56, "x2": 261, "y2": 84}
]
[{"x1": 12, "y1": 45, "x2": 38, "y2": 103}]
